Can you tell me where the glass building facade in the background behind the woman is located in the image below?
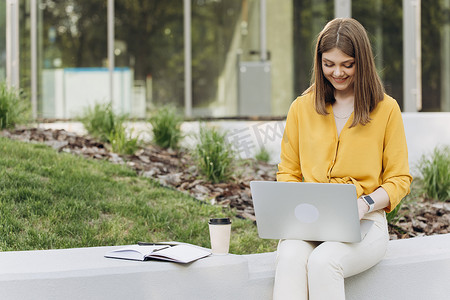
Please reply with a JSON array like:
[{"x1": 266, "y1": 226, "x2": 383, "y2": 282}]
[{"x1": 0, "y1": 0, "x2": 450, "y2": 119}]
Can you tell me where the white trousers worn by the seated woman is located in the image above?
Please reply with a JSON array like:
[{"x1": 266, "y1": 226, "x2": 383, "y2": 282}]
[{"x1": 273, "y1": 210, "x2": 389, "y2": 300}]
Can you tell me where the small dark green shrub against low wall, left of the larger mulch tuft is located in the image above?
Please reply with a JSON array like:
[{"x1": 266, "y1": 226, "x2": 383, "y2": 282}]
[{"x1": 149, "y1": 106, "x2": 183, "y2": 149}]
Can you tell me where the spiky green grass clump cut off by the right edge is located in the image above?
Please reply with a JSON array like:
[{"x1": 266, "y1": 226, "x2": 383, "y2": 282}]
[{"x1": 418, "y1": 146, "x2": 450, "y2": 201}]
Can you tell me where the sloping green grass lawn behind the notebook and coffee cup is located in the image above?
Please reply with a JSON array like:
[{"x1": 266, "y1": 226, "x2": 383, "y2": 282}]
[{"x1": 0, "y1": 138, "x2": 277, "y2": 254}]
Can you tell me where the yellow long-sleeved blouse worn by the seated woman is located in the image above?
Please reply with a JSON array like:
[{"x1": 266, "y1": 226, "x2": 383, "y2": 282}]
[{"x1": 277, "y1": 93, "x2": 412, "y2": 212}]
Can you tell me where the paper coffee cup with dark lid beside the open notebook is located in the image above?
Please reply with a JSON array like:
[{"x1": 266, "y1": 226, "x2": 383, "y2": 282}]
[{"x1": 208, "y1": 218, "x2": 231, "y2": 255}]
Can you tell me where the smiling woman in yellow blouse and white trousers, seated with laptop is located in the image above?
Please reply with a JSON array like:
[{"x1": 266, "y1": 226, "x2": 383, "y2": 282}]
[{"x1": 274, "y1": 19, "x2": 412, "y2": 299}]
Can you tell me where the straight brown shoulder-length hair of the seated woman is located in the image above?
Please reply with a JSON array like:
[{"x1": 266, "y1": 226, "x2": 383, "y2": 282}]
[{"x1": 303, "y1": 18, "x2": 384, "y2": 127}]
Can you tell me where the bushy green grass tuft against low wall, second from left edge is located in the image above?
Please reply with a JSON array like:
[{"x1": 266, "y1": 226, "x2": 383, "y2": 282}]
[{"x1": 80, "y1": 103, "x2": 125, "y2": 143}]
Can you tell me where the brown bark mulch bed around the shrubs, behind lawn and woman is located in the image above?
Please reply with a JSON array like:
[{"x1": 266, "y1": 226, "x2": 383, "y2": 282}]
[{"x1": 0, "y1": 128, "x2": 450, "y2": 239}]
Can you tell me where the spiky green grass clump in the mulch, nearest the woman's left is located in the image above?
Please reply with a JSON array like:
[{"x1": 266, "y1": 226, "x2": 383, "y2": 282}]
[{"x1": 194, "y1": 127, "x2": 235, "y2": 183}]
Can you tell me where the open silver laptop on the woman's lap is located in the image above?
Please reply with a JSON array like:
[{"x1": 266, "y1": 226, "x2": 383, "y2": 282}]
[{"x1": 250, "y1": 181, "x2": 373, "y2": 242}]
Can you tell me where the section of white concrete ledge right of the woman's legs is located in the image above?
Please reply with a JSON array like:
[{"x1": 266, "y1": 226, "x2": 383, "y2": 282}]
[{"x1": 345, "y1": 234, "x2": 450, "y2": 300}]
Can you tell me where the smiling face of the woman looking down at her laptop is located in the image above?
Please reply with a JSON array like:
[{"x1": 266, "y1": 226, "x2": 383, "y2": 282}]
[{"x1": 322, "y1": 48, "x2": 356, "y2": 93}]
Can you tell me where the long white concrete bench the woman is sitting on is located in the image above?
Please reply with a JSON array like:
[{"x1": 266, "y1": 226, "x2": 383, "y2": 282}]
[{"x1": 0, "y1": 234, "x2": 450, "y2": 300}]
